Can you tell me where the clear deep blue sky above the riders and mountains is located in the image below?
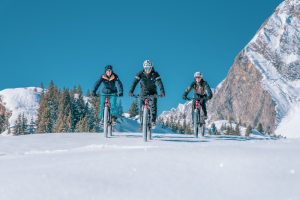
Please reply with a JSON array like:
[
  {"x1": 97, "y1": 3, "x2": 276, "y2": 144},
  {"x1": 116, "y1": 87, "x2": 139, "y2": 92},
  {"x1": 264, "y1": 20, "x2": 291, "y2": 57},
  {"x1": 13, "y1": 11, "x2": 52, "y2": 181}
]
[{"x1": 0, "y1": 0, "x2": 282, "y2": 111}]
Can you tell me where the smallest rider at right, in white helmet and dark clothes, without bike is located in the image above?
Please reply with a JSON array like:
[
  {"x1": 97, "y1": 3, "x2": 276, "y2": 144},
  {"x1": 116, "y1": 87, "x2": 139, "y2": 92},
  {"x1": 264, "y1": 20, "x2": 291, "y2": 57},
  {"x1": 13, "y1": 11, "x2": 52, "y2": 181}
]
[{"x1": 182, "y1": 72, "x2": 213, "y2": 124}]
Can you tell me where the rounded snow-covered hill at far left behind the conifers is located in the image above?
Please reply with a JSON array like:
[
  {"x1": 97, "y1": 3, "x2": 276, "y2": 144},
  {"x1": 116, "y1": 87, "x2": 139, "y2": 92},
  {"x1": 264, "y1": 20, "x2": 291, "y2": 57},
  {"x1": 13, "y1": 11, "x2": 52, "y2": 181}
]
[{"x1": 0, "y1": 87, "x2": 42, "y2": 126}]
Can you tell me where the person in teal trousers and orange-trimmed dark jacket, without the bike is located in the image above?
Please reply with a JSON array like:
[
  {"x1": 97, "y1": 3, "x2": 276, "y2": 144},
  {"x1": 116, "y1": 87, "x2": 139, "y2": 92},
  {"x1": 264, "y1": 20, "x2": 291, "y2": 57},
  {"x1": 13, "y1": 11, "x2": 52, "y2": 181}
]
[{"x1": 93, "y1": 65, "x2": 123, "y2": 125}]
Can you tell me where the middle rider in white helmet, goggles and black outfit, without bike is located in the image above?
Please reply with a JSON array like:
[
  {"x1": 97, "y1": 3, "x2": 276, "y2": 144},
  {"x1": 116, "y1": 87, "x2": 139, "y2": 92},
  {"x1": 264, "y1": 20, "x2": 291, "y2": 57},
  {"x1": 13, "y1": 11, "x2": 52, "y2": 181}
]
[{"x1": 129, "y1": 60, "x2": 165, "y2": 128}]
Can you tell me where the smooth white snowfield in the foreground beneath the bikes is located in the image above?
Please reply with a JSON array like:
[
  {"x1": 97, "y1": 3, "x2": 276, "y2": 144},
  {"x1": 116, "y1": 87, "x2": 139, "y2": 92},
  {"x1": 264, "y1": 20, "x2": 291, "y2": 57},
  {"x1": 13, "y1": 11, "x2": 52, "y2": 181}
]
[{"x1": 0, "y1": 133, "x2": 300, "y2": 200}]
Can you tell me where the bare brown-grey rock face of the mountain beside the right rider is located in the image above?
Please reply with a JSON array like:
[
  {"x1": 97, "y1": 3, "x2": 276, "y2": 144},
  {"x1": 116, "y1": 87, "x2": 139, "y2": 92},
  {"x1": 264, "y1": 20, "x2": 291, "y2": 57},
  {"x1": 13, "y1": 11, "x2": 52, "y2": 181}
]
[{"x1": 208, "y1": 52, "x2": 276, "y2": 132}]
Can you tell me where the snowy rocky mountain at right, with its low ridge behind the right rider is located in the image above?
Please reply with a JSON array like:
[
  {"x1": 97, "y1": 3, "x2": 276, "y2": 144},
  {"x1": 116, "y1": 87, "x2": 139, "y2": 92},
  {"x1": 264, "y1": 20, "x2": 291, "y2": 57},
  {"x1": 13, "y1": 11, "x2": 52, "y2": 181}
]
[{"x1": 160, "y1": 0, "x2": 300, "y2": 137}]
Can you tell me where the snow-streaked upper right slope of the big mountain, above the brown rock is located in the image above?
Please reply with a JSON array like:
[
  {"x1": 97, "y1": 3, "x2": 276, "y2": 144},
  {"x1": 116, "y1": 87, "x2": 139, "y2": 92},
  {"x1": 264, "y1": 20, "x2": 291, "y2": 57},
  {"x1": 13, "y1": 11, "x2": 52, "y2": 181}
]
[{"x1": 245, "y1": 0, "x2": 300, "y2": 137}]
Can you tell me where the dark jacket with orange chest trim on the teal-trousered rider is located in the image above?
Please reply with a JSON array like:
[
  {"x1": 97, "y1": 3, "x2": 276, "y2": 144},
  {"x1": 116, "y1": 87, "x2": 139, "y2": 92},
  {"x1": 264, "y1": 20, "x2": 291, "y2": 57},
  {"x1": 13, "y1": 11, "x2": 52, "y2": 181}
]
[{"x1": 93, "y1": 73, "x2": 123, "y2": 95}]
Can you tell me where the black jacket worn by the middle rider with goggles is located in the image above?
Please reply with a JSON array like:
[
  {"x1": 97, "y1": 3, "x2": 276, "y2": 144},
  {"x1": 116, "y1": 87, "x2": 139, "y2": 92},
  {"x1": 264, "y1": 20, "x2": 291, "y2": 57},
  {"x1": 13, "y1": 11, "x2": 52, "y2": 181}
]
[{"x1": 129, "y1": 69, "x2": 165, "y2": 96}]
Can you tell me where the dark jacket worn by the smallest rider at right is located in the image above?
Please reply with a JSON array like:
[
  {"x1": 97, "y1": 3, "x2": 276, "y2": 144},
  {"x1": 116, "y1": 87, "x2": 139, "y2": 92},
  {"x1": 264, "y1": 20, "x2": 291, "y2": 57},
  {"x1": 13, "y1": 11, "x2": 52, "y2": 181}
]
[{"x1": 183, "y1": 79, "x2": 213, "y2": 99}]
